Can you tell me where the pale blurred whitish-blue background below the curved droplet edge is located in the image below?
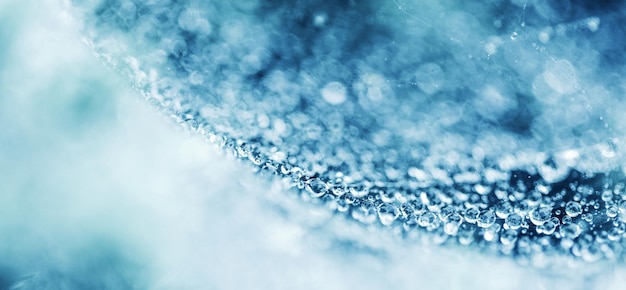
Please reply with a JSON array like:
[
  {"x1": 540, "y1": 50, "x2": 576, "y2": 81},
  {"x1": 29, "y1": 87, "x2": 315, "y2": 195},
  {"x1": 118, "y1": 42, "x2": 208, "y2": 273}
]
[{"x1": 0, "y1": 0, "x2": 626, "y2": 289}]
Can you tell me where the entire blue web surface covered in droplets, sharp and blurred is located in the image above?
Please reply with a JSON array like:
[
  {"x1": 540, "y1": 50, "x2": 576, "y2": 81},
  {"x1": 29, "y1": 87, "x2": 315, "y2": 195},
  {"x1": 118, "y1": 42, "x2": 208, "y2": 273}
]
[{"x1": 70, "y1": 0, "x2": 626, "y2": 264}]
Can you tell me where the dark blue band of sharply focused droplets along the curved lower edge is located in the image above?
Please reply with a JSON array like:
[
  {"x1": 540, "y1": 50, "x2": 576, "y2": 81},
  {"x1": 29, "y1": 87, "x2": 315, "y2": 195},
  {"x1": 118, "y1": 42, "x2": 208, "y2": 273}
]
[{"x1": 197, "y1": 127, "x2": 626, "y2": 266}]
